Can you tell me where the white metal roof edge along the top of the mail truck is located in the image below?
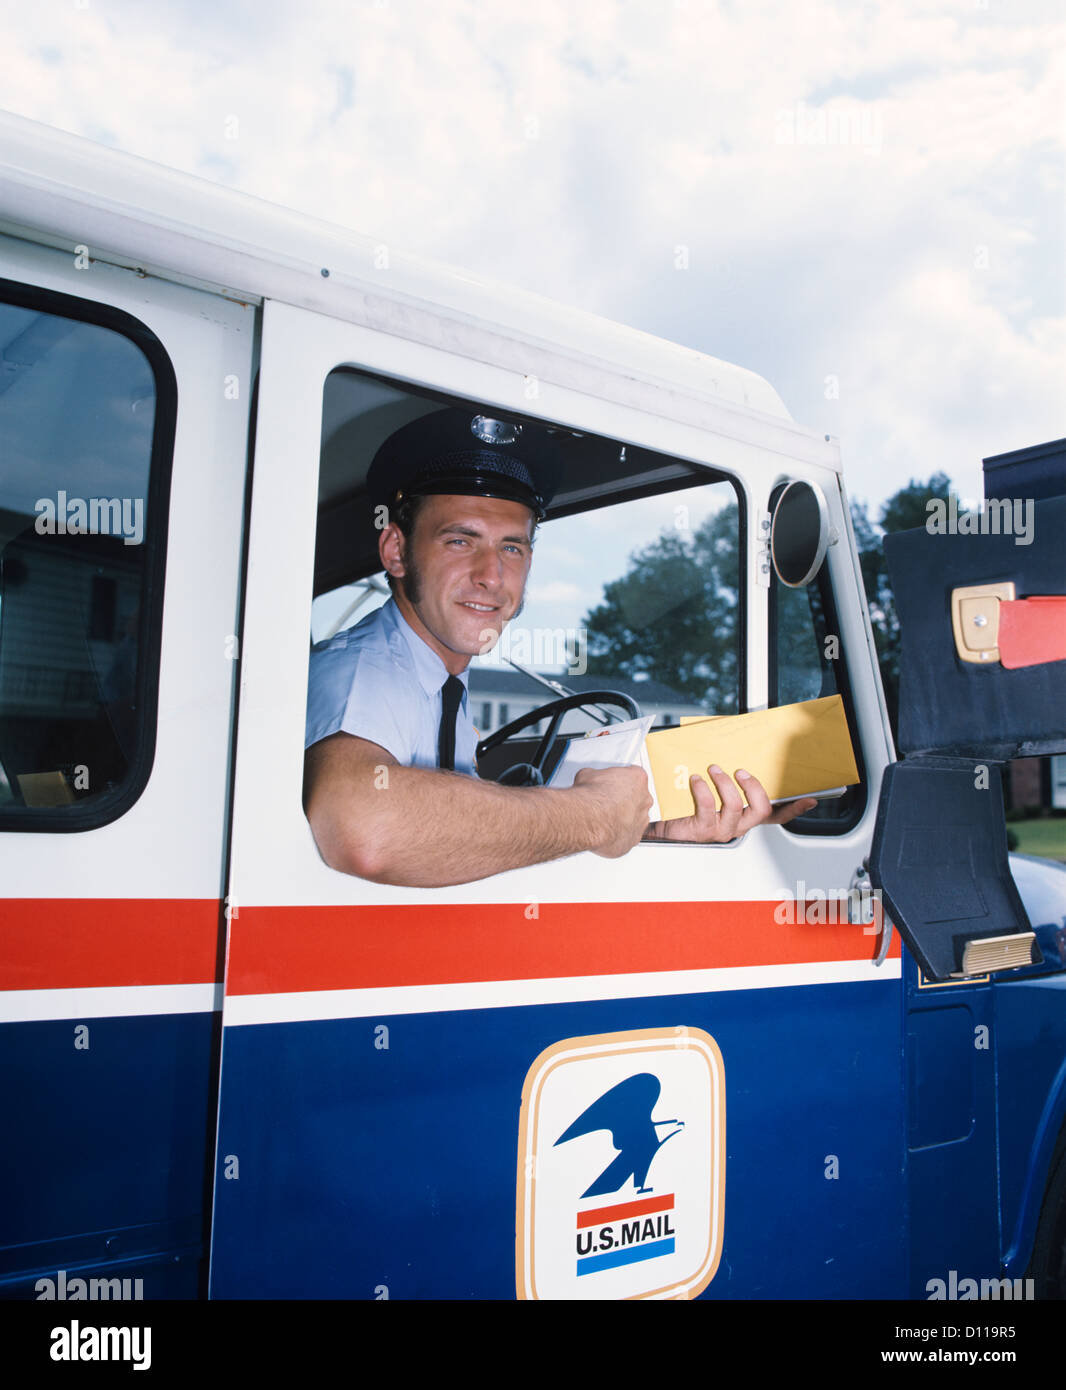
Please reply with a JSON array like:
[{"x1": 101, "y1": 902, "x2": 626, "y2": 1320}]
[{"x1": 0, "y1": 111, "x2": 813, "y2": 435}]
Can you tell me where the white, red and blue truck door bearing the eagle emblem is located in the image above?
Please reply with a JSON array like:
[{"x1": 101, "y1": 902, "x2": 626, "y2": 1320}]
[{"x1": 211, "y1": 300, "x2": 905, "y2": 1300}]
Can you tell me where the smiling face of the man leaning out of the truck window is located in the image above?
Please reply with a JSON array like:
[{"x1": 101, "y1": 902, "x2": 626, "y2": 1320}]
[{"x1": 382, "y1": 496, "x2": 532, "y2": 674}]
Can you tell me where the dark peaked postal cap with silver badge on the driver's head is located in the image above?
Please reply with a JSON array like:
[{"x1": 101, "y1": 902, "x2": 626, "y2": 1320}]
[{"x1": 367, "y1": 409, "x2": 559, "y2": 521}]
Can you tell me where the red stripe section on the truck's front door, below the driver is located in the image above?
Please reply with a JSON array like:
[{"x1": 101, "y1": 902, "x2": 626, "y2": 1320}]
[{"x1": 227, "y1": 902, "x2": 899, "y2": 994}]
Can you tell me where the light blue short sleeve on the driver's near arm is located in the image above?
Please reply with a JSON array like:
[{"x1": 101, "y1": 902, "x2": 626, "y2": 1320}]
[{"x1": 304, "y1": 645, "x2": 417, "y2": 766}]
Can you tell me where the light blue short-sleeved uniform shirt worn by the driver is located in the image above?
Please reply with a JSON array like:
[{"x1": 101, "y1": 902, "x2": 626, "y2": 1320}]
[{"x1": 304, "y1": 599, "x2": 477, "y2": 776}]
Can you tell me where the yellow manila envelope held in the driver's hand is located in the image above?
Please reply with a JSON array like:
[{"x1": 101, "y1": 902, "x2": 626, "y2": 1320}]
[{"x1": 646, "y1": 695, "x2": 859, "y2": 820}]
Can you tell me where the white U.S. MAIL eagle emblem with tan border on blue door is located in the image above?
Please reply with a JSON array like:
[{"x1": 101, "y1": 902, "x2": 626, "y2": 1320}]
[{"x1": 516, "y1": 1026, "x2": 725, "y2": 1298}]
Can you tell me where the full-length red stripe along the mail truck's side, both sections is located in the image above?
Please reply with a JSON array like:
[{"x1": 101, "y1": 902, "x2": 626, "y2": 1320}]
[{"x1": 0, "y1": 898, "x2": 899, "y2": 995}]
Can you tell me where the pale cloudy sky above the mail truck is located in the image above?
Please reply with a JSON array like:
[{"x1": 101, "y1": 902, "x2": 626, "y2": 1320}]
[{"x1": 0, "y1": 0, "x2": 1066, "y2": 506}]
